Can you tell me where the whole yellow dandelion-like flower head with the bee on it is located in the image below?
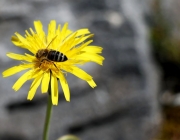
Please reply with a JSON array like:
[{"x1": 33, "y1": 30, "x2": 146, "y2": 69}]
[{"x1": 3, "y1": 20, "x2": 104, "y2": 105}]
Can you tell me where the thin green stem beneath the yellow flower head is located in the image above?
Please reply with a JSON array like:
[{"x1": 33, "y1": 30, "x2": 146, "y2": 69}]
[{"x1": 43, "y1": 84, "x2": 52, "y2": 140}]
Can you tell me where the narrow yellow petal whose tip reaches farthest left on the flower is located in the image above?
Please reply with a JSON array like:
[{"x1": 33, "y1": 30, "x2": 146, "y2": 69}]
[{"x1": 2, "y1": 64, "x2": 34, "y2": 77}]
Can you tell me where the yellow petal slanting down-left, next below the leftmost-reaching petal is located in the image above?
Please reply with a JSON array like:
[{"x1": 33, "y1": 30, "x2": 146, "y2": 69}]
[{"x1": 12, "y1": 70, "x2": 32, "y2": 91}]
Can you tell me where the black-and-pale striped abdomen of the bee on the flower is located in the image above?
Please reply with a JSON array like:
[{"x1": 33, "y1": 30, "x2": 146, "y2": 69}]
[{"x1": 47, "y1": 50, "x2": 68, "y2": 62}]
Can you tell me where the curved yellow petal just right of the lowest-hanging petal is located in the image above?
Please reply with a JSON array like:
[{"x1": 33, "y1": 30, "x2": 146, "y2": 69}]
[{"x1": 56, "y1": 72, "x2": 70, "y2": 101}]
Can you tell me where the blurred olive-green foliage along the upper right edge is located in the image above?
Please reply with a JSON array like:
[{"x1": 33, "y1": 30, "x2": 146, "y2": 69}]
[{"x1": 150, "y1": 0, "x2": 180, "y2": 65}]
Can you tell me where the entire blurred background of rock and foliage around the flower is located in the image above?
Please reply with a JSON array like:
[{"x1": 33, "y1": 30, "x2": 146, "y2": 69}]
[{"x1": 0, "y1": 0, "x2": 180, "y2": 140}]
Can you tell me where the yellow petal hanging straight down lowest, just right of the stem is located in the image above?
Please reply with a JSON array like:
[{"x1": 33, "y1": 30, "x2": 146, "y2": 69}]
[{"x1": 51, "y1": 74, "x2": 58, "y2": 105}]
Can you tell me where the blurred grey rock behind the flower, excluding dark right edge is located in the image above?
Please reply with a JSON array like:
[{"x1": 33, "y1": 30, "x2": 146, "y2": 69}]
[{"x1": 0, "y1": 0, "x2": 160, "y2": 140}]
